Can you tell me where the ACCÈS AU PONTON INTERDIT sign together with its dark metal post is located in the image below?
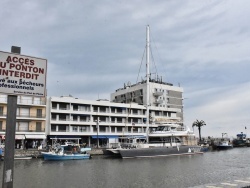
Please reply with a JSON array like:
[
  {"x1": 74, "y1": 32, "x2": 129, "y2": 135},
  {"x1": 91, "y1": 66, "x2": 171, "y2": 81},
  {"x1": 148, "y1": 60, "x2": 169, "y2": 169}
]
[{"x1": 0, "y1": 46, "x2": 47, "y2": 188}]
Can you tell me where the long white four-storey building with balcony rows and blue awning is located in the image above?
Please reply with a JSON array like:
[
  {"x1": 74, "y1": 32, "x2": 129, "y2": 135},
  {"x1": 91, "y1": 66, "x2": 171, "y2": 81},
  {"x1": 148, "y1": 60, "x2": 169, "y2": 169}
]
[{"x1": 47, "y1": 96, "x2": 146, "y2": 145}]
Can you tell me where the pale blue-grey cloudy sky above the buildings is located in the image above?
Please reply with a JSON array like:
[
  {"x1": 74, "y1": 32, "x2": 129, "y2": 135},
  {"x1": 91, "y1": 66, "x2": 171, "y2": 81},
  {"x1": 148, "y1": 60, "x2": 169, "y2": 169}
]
[{"x1": 0, "y1": 0, "x2": 250, "y2": 137}]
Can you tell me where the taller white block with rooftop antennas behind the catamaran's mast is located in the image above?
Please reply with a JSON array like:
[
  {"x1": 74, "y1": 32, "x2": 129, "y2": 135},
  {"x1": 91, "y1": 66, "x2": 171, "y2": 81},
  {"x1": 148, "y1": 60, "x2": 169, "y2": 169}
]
[{"x1": 111, "y1": 79, "x2": 183, "y2": 125}]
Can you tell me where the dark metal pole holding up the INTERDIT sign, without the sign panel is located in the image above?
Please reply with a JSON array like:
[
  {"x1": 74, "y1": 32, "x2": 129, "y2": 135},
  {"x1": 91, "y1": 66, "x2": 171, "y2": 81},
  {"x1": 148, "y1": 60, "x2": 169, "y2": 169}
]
[{"x1": 2, "y1": 46, "x2": 21, "y2": 188}]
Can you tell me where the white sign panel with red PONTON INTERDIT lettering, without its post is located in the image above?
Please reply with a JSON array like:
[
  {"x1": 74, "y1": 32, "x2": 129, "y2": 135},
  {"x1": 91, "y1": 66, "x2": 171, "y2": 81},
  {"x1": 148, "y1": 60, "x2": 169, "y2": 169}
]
[{"x1": 0, "y1": 51, "x2": 47, "y2": 97}]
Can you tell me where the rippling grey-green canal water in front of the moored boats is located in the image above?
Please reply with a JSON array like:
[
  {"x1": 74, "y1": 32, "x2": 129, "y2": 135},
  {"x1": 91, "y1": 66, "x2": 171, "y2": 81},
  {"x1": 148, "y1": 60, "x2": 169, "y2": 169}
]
[{"x1": 0, "y1": 148, "x2": 250, "y2": 188}]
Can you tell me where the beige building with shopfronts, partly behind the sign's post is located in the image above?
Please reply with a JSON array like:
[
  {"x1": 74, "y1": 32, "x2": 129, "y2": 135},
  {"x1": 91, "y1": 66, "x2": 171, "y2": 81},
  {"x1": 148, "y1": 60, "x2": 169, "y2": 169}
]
[{"x1": 0, "y1": 94, "x2": 46, "y2": 148}]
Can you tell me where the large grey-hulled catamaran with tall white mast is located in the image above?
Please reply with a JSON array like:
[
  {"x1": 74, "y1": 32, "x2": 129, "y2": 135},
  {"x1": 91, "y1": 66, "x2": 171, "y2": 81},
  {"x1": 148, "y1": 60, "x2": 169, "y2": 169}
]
[{"x1": 106, "y1": 26, "x2": 203, "y2": 158}]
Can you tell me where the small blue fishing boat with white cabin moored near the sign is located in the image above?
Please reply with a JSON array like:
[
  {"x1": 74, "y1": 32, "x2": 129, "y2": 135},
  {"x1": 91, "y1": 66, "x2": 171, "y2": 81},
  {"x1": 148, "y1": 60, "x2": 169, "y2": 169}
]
[{"x1": 41, "y1": 144, "x2": 91, "y2": 161}]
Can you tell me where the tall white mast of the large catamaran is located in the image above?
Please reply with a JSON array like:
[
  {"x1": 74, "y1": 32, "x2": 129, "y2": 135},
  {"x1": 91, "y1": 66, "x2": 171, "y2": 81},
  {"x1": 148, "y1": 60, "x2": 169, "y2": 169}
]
[{"x1": 146, "y1": 25, "x2": 150, "y2": 142}]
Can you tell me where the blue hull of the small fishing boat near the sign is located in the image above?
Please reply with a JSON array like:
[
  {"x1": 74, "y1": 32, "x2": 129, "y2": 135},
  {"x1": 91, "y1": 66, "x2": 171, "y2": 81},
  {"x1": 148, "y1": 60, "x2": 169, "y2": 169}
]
[{"x1": 42, "y1": 152, "x2": 90, "y2": 161}]
